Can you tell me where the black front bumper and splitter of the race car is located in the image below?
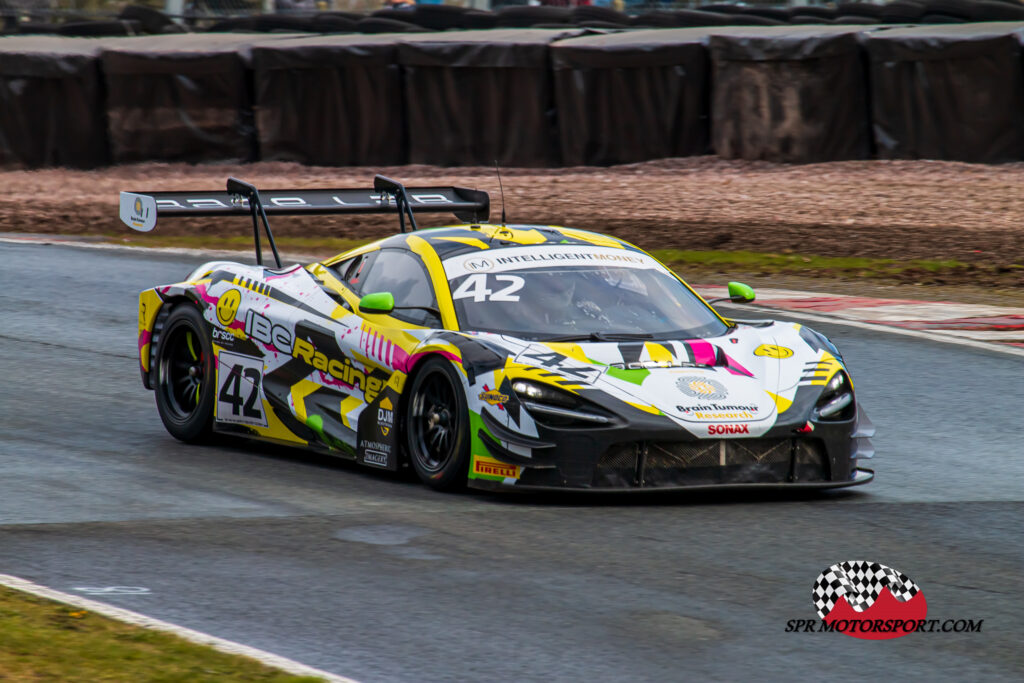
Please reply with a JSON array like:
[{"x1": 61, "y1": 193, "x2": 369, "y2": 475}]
[{"x1": 469, "y1": 401, "x2": 873, "y2": 492}]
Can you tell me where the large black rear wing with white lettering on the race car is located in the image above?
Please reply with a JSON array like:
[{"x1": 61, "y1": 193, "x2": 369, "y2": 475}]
[{"x1": 121, "y1": 175, "x2": 490, "y2": 266}]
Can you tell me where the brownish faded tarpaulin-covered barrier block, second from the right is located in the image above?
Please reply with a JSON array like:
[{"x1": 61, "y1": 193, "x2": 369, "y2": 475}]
[{"x1": 709, "y1": 26, "x2": 871, "y2": 163}]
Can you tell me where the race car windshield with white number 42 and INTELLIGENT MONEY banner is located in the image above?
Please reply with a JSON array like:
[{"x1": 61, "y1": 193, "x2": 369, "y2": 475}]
[{"x1": 444, "y1": 245, "x2": 728, "y2": 341}]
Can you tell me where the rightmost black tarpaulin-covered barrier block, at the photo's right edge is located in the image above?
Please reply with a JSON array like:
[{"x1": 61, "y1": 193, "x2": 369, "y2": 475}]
[{"x1": 864, "y1": 22, "x2": 1024, "y2": 163}]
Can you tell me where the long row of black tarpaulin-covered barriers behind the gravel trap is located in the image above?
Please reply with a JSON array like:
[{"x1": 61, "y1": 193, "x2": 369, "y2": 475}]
[{"x1": 0, "y1": 24, "x2": 1024, "y2": 168}]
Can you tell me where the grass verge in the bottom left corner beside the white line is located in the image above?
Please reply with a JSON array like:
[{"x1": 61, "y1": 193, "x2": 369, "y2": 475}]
[{"x1": 0, "y1": 587, "x2": 322, "y2": 683}]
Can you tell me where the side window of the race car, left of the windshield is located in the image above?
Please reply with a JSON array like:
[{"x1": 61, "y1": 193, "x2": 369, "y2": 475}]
[{"x1": 361, "y1": 249, "x2": 440, "y2": 327}]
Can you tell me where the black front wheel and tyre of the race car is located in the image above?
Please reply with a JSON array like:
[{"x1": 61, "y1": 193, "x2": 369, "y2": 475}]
[{"x1": 404, "y1": 357, "x2": 469, "y2": 490}]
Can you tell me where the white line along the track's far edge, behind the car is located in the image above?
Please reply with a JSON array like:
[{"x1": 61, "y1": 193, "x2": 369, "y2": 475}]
[{"x1": 0, "y1": 232, "x2": 1024, "y2": 357}]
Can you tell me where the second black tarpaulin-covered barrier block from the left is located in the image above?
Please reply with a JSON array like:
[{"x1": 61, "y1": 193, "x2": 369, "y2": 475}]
[{"x1": 100, "y1": 33, "x2": 299, "y2": 163}]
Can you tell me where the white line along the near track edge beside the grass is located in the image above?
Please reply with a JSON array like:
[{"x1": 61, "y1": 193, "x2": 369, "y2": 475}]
[{"x1": 0, "y1": 573, "x2": 357, "y2": 683}]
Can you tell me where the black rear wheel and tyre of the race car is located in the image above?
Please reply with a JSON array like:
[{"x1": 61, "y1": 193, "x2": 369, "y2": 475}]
[{"x1": 155, "y1": 304, "x2": 216, "y2": 443}]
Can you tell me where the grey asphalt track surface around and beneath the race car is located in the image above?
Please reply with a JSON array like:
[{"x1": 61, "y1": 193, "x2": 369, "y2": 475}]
[{"x1": 0, "y1": 244, "x2": 1024, "y2": 681}]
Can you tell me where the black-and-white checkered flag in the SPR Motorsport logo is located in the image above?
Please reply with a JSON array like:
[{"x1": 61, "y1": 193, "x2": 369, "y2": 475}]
[{"x1": 811, "y1": 561, "x2": 921, "y2": 618}]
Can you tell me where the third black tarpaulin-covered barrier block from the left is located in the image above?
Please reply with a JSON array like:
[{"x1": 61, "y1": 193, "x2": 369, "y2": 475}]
[{"x1": 250, "y1": 34, "x2": 408, "y2": 166}]
